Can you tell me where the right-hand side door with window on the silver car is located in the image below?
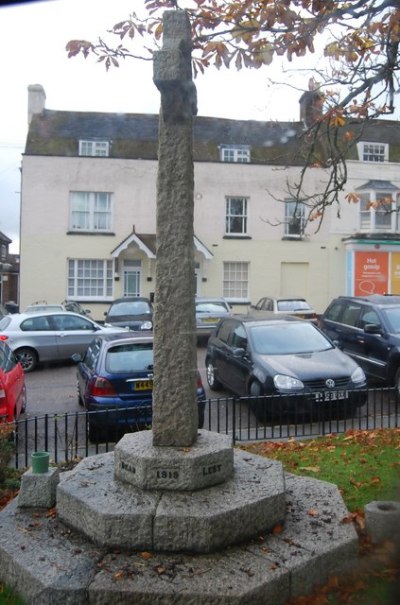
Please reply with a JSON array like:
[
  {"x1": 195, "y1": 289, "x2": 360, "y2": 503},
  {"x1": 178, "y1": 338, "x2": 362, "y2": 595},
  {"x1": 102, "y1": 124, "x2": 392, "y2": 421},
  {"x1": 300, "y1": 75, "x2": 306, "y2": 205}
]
[{"x1": 49, "y1": 313, "x2": 95, "y2": 359}]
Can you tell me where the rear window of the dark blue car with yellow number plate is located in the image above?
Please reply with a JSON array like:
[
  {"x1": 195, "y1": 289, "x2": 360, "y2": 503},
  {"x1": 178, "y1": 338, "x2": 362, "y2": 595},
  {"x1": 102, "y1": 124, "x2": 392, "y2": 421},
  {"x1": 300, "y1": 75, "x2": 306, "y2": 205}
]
[{"x1": 105, "y1": 342, "x2": 153, "y2": 374}]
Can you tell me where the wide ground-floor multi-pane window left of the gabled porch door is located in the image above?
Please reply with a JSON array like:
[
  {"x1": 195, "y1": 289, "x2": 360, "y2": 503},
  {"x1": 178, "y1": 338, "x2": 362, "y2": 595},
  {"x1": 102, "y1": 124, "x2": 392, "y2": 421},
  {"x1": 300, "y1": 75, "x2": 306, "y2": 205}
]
[{"x1": 68, "y1": 259, "x2": 113, "y2": 300}]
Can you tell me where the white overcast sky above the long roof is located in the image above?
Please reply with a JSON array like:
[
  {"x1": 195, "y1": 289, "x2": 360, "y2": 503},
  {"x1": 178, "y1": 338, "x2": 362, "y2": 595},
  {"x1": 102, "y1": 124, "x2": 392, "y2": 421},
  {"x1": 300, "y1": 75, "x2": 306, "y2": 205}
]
[{"x1": 0, "y1": 0, "x2": 328, "y2": 252}]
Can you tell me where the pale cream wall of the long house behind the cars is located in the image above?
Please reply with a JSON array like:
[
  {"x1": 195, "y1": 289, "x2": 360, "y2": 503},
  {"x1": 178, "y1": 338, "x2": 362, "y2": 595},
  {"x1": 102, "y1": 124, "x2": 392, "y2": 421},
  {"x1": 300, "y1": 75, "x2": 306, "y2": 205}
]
[{"x1": 20, "y1": 149, "x2": 390, "y2": 319}]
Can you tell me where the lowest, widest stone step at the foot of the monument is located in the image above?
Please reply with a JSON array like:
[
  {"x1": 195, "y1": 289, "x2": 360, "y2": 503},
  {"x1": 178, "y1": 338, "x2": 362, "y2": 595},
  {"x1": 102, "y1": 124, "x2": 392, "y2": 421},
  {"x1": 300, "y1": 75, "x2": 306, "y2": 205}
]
[{"x1": 0, "y1": 472, "x2": 358, "y2": 605}]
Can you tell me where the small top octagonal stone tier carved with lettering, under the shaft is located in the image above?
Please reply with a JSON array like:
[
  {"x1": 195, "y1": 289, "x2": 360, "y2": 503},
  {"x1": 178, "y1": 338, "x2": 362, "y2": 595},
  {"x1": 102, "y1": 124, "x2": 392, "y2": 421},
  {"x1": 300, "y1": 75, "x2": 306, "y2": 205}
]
[{"x1": 114, "y1": 430, "x2": 233, "y2": 491}]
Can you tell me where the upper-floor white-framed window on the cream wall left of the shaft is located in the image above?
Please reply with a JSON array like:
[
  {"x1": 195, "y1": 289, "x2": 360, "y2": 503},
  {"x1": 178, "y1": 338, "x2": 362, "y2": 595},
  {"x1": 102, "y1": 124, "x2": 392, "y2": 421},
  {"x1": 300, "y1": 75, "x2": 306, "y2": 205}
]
[{"x1": 70, "y1": 191, "x2": 111, "y2": 232}]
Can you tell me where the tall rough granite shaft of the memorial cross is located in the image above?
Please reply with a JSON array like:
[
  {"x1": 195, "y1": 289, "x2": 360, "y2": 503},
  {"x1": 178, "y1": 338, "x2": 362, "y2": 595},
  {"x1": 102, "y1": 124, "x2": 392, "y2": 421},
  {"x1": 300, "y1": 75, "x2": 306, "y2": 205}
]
[{"x1": 152, "y1": 10, "x2": 198, "y2": 447}]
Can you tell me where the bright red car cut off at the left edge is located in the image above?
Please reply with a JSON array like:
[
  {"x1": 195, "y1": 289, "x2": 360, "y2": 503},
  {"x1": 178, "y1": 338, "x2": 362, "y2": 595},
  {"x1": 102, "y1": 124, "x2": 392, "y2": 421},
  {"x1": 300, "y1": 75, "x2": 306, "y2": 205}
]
[{"x1": 0, "y1": 340, "x2": 26, "y2": 422}]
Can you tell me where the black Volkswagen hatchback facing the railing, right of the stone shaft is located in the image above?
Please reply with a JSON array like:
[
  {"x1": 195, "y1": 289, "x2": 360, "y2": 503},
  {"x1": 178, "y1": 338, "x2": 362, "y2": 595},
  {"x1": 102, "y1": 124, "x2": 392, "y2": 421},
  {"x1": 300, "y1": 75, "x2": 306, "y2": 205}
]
[{"x1": 206, "y1": 314, "x2": 366, "y2": 421}]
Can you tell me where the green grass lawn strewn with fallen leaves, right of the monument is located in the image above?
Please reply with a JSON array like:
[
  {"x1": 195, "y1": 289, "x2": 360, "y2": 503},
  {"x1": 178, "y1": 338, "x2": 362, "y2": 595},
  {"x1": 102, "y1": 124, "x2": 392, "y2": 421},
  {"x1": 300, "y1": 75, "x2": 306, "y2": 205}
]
[{"x1": 241, "y1": 429, "x2": 400, "y2": 605}]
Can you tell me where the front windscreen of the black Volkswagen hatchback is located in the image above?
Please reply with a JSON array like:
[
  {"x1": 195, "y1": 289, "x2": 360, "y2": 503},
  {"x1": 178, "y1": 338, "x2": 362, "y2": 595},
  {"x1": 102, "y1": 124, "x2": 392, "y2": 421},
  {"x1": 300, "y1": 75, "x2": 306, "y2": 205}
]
[{"x1": 250, "y1": 321, "x2": 332, "y2": 355}]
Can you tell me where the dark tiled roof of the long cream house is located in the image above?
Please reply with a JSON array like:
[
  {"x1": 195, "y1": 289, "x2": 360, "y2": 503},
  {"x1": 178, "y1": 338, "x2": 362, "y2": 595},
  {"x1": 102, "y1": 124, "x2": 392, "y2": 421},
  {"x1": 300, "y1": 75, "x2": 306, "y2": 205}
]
[{"x1": 25, "y1": 109, "x2": 400, "y2": 165}]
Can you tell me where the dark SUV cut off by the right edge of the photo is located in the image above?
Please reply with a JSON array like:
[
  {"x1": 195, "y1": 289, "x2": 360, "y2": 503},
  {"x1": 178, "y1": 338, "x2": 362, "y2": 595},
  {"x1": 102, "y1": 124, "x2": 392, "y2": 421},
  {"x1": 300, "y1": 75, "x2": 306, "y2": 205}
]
[{"x1": 320, "y1": 294, "x2": 400, "y2": 390}]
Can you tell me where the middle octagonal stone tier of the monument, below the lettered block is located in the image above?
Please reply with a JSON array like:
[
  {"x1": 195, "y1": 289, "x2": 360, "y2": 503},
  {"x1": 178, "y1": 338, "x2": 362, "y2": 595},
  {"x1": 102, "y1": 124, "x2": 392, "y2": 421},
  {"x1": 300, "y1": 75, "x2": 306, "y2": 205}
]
[{"x1": 57, "y1": 450, "x2": 285, "y2": 552}]
